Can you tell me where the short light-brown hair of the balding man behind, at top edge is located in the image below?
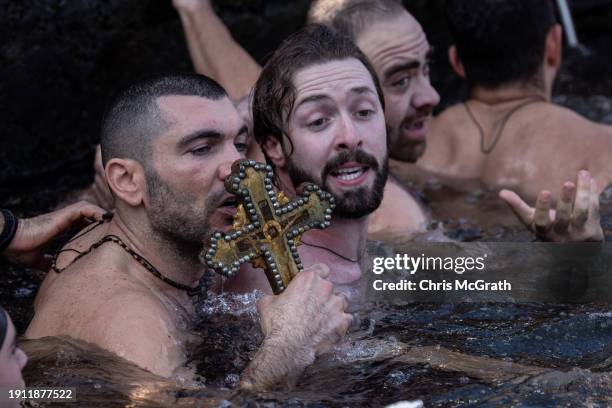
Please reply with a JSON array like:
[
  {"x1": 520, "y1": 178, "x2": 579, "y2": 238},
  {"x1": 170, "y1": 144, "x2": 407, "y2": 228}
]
[{"x1": 308, "y1": 0, "x2": 406, "y2": 41}]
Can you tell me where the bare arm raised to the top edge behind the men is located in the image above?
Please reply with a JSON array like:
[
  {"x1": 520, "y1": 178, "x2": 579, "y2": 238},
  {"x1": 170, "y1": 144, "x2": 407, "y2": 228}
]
[{"x1": 173, "y1": 0, "x2": 261, "y2": 103}]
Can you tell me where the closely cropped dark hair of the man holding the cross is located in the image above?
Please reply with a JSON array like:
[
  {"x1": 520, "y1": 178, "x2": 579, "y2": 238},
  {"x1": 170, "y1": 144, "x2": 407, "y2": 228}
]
[{"x1": 100, "y1": 73, "x2": 227, "y2": 167}]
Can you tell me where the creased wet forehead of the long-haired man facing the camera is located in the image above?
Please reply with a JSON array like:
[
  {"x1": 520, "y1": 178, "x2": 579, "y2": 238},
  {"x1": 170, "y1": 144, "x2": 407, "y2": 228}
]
[{"x1": 293, "y1": 58, "x2": 376, "y2": 106}]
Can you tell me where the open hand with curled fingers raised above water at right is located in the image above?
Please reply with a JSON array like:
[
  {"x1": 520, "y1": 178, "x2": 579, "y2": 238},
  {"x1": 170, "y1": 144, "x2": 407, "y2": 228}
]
[{"x1": 499, "y1": 170, "x2": 604, "y2": 242}]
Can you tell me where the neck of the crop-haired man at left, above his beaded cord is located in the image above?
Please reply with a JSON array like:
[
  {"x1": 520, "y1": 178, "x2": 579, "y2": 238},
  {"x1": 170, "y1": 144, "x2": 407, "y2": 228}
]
[{"x1": 109, "y1": 211, "x2": 204, "y2": 293}]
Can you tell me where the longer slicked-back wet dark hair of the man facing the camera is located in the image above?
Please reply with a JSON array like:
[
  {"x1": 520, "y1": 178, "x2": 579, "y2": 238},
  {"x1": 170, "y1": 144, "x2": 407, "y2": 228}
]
[{"x1": 253, "y1": 24, "x2": 385, "y2": 162}]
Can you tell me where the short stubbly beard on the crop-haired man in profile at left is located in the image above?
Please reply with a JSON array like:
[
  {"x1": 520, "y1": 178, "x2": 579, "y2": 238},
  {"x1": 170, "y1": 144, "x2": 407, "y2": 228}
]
[{"x1": 146, "y1": 170, "x2": 225, "y2": 247}]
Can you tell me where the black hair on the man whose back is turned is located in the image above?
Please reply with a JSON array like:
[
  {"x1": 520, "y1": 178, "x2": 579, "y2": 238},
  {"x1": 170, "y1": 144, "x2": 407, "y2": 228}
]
[{"x1": 446, "y1": 0, "x2": 555, "y2": 89}]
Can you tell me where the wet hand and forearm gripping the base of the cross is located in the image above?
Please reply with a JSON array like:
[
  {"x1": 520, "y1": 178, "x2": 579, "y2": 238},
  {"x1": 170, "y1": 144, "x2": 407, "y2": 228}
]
[{"x1": 240, "y1": 264, "x2": 352, "y2": 391}]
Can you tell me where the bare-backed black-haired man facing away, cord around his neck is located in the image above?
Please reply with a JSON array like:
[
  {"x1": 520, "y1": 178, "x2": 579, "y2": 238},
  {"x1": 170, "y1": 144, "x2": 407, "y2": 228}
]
[{"x1": 418, "y1": 0, "x2": 612, "y2": 202}]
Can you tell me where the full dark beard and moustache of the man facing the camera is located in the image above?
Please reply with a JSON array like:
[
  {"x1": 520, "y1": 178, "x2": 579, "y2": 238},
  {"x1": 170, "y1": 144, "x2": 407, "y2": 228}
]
[{"x1": 287, "y1": 150, "x2": 389, "y2": 219}]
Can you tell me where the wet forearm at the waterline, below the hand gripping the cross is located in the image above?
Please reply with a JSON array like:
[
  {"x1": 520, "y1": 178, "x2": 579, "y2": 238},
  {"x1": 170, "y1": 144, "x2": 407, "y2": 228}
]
[{"x1": 240, "y1": 339, "x2": 315, "y2": 391}]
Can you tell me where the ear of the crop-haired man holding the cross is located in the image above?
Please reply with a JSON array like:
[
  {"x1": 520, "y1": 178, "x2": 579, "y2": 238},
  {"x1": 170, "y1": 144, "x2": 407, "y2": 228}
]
[{"x1": 104, "y1": 159, "x2": 146, "y2": 207}]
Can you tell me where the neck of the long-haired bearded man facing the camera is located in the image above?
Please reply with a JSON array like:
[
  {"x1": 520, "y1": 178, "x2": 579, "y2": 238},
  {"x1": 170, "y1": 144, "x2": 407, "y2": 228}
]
[{"x1": 302, "y1": 216, "x2": 368, "y2": 261}]
